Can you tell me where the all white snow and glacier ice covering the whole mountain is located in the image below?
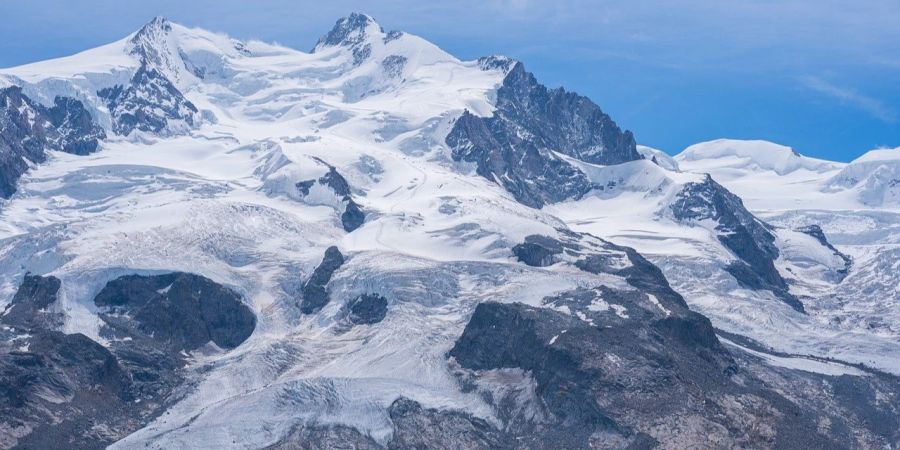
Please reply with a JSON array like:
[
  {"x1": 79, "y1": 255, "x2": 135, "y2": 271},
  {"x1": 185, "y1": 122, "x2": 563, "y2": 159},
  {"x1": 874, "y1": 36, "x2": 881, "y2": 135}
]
[{"x1": 0, "y1": 14, "x2": 900, "y2": 448}]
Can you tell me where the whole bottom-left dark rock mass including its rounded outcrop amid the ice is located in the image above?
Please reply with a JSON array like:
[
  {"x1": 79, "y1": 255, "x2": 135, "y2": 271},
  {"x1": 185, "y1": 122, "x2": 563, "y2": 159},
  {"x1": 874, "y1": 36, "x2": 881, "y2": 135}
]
[{"x1": 0, "y1": 273, "x2": 255, "y2": 448}]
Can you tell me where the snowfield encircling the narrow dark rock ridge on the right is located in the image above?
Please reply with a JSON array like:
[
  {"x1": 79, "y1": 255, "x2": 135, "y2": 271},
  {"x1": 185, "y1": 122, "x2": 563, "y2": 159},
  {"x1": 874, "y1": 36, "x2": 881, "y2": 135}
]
[{"x1": 543, "y1": 140, "x2": 900, "y2": 373}]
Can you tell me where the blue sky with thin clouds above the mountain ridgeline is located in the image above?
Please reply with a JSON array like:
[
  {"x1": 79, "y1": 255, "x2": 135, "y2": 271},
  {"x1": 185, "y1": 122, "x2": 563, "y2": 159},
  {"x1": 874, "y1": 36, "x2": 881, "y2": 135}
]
[{"x1": 0, "y1": 0, "x2": 900, "y2": 161}]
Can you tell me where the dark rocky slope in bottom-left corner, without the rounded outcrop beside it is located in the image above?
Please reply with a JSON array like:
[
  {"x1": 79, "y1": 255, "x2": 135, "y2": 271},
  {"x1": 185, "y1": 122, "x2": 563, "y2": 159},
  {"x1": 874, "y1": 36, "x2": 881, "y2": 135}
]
[{"x1": 0, "y1": 275, "x2": 194, "y2": 448}]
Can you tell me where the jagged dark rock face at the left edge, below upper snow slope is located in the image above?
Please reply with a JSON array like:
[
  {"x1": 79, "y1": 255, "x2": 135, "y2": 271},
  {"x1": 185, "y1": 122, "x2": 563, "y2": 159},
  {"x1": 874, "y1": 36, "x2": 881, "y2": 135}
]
[{"x1": 0, "y1": 86, "x2": 106, "y2": 198}]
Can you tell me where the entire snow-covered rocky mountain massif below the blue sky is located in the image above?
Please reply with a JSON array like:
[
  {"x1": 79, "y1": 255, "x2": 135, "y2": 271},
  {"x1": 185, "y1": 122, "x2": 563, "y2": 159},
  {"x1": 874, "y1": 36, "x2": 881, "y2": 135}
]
[{"x1": 0, "y1": 14, "x2": 900, "y2": 448}]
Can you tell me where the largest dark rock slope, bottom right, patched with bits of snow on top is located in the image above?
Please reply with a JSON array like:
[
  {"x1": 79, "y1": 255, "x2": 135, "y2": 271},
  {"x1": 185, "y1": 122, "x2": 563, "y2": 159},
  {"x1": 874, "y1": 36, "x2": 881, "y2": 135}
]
[{"x1": 449, "y1": 298, "x2": 897, "y2": 448}]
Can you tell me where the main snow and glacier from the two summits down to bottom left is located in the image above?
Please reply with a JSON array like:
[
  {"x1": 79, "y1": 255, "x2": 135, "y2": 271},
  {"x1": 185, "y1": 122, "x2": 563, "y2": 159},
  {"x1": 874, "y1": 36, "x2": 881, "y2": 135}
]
[{"x1": 0, "y1": 14, "x2": 628, "y2": 448}]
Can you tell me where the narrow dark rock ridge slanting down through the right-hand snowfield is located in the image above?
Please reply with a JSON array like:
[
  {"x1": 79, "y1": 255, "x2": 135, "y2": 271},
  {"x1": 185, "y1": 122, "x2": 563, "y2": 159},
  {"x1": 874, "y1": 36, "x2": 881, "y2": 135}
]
[{"x1": 671, "y1": 176, "x2": 804, "y2": 312}]
